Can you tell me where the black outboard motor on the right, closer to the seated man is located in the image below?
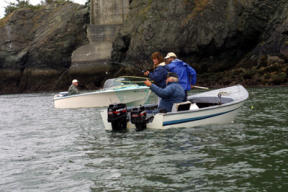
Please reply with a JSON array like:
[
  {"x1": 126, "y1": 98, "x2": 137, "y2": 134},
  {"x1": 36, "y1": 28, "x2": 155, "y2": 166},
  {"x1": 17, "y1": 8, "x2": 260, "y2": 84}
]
[{"x1": 131, "y1": 106, "x2": 148, "y2": 131}]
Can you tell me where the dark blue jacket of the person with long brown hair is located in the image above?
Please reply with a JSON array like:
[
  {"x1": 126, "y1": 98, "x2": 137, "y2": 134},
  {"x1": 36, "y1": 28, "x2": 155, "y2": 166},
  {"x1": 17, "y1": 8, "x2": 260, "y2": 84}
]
[{"x1": 148, "y1": 65, "x2": 168, "y2": 88}]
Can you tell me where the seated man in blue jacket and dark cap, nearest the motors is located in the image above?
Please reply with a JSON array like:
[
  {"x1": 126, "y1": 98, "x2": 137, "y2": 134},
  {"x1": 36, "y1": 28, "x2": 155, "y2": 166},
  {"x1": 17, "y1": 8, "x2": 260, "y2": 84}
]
[{"x1": 144, "y1": 73, "x2": 185, "y2": 112}]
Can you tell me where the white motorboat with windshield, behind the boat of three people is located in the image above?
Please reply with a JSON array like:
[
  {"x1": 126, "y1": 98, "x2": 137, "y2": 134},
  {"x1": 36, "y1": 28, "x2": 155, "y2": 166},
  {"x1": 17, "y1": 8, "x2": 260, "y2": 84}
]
[{"x1": 54, "y1": 77, "x2": 151, "y2": 108}]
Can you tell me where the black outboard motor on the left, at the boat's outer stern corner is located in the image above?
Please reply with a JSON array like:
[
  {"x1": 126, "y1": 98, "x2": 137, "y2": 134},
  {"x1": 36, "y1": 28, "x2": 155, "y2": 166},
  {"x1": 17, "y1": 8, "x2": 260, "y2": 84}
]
[{"x1": 107, "y1": 103, "x2": 127, "y2": 131}]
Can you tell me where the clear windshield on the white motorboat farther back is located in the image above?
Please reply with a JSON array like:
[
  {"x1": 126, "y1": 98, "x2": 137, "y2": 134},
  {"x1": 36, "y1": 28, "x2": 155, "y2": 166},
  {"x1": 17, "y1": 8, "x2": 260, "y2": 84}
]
[{"x1": 103, "y1": 77, "x2": 144, "y2": 89}]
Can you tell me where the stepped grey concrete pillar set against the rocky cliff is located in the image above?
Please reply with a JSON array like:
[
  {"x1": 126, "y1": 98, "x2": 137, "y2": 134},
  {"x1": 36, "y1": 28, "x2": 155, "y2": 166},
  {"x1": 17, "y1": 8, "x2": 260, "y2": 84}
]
[{"x1": 69, "y1": 0, "x2": 129, "y2": 75}]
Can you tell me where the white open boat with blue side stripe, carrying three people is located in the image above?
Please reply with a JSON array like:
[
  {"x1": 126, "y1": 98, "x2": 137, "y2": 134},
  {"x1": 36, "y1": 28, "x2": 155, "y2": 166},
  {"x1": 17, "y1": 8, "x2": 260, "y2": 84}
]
[{"x1": 101, "y1": 85, "x2": 249, "y2": 130}]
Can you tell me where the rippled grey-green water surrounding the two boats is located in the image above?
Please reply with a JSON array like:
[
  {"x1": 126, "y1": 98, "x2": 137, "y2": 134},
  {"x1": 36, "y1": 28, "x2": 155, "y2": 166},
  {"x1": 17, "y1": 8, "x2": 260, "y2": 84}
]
[{"x1": 0, "y1": 88, "x2": 288, "y2": 192}]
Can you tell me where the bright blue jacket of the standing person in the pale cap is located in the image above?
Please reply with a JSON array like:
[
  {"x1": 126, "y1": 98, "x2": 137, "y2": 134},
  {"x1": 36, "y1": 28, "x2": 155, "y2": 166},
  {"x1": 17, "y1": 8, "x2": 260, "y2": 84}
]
[{"x1": 165, "y1": 59, "x2": 197, "y2": 91}]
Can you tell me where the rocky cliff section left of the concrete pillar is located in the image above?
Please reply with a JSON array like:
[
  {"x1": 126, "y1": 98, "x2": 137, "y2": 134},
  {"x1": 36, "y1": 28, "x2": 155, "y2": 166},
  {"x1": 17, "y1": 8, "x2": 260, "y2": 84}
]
[{"x1": 0, "y1": 3, "x2": 89, "y2": 93}]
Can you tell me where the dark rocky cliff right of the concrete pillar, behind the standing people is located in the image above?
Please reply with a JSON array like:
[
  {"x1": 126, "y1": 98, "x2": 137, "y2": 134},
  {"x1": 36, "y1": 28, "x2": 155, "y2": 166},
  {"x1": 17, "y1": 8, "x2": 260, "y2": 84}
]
[{"x1": 112, "y1": 0, "x2": 288, "y2": 86}]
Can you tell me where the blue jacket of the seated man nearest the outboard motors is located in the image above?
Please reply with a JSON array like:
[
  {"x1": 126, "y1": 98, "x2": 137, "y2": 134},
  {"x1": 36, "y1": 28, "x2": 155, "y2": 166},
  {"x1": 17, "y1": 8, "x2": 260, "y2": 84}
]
[{"x1": 150, "y1": 82, "x2": 185, "y2": 112}]
